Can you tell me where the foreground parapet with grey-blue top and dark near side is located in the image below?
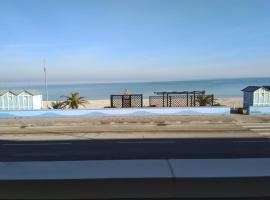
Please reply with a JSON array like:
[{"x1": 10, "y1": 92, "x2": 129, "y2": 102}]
[{"x1": 0, "y1": 158, "x2": 270, "y2": 199}]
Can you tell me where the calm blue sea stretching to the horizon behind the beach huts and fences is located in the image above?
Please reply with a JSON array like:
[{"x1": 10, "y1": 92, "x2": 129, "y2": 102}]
[{"x1": 0, "y1": 78, "x2": 270, "y2": 100}]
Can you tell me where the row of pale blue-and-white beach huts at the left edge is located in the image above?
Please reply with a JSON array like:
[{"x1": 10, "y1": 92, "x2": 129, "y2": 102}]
[{"x1": 0, "y1": 90, "x2": 42, "y2": 110}]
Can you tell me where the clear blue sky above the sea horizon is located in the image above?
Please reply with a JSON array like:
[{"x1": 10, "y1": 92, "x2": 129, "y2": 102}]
[{"x1": 0, "y1": 0, "x2": 270, "y2": 82}]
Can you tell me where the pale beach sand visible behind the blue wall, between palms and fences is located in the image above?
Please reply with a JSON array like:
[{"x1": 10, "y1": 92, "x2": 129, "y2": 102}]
[{"x1": 43, "y1": 97, "x2": 243, "y2": 108}]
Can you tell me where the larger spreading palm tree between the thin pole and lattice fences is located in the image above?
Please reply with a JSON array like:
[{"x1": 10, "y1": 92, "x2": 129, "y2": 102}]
[{"x1": 62, "y1": 92, "x2": 87, "y2": 109}]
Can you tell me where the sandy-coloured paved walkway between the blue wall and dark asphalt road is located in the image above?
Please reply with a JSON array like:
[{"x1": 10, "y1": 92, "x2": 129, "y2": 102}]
[{"x1": 0, "y1": 115, "x2": 270, "y2": 141}]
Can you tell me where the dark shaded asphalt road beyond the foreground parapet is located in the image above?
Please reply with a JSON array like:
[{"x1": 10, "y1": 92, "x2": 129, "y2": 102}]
[{"x1": 0, "y1": 138, "x2": 270, "y2": 161}]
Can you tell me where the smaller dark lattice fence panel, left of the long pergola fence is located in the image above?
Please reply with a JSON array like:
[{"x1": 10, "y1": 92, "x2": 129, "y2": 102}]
[{"x1": 111, "y1": 94, "x2": 143, "y2": 108}]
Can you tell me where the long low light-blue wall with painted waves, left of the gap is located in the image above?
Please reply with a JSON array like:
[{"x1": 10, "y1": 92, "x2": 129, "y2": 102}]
[{"x1": 0, "y1": 106, "x2": 230, "y2": 118}]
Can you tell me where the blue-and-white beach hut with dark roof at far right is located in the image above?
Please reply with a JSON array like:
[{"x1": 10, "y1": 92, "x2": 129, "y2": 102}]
[{"x1": 242, "y1": 86, "x2": 270, "y2": 108}]
